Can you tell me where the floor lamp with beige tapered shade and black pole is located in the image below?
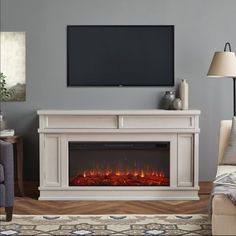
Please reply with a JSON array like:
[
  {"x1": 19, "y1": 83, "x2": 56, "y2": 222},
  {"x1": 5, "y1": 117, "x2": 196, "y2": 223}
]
[{"x1": 207, "y1": 42, "x2": 236, "y2": 116}]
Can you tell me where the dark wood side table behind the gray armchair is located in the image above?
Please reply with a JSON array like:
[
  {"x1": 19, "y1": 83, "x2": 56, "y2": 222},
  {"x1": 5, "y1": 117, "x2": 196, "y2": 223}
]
[{"x1": 0, "y1": 136, "x2": 24, "y2": 197}]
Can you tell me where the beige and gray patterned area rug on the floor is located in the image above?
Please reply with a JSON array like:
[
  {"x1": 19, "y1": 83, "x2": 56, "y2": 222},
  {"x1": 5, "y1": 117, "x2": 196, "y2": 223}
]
[{"x1": 0, "y1": 215, "x2": 211, "y2": 236}]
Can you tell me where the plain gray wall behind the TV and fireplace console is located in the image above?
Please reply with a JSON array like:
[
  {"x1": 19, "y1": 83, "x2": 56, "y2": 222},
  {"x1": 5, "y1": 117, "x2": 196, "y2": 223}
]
[{"x1": 1, "y1": 0, "x2": 236, "y2": 180}]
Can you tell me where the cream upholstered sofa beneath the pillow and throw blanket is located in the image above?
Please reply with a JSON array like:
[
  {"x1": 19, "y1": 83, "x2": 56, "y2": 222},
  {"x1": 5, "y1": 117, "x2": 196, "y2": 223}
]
[{"x1": 212, "y1": 120, "x2": 236, "y2": 235}]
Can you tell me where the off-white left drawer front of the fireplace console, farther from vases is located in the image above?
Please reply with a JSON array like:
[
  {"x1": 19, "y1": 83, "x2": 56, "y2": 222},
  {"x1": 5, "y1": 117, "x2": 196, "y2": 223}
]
[{"x1": 45, "y1": 115, "x2": 117, "y2": 129}]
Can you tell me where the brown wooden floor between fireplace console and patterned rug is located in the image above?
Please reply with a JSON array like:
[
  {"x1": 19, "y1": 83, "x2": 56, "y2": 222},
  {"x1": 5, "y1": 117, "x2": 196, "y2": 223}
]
[{"x1": 0, "y1": 182, "x2": 212, "y2": 215}]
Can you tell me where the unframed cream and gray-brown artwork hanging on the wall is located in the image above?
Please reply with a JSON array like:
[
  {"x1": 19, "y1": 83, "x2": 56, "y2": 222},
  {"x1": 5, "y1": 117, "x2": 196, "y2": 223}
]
[{"x1": 0, "y1": 32, "x2": 26, "y2": 101}]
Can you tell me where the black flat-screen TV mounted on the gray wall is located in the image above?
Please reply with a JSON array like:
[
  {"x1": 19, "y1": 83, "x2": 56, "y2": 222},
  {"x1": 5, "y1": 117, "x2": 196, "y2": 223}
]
[{"x1": 67, "y1": 25, "x2": 174, "y2": 86}]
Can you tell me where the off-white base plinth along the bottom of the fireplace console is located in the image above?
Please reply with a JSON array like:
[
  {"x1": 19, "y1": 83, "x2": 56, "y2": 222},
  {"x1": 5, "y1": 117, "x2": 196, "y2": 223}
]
[{"x1": 39, "y1": 187, "x2": 199, "y2": 201}]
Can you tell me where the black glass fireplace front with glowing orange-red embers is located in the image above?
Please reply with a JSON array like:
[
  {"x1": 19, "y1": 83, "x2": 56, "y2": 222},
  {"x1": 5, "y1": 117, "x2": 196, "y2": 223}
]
[{"x1": 68, "y1": 141, "x2": 170, "y2": 186}]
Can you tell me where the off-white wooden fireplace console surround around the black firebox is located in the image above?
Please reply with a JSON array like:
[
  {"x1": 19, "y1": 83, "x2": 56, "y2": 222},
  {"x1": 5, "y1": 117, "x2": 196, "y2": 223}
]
[{"x1": 38, "y1": 110, "x2": 200, "y2": 200}]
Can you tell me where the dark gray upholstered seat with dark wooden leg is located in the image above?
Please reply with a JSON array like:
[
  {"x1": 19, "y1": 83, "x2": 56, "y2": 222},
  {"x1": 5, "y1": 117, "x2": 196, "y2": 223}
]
[{"x1": 0, "y1": 140, "x2": 14, "y2": 221}]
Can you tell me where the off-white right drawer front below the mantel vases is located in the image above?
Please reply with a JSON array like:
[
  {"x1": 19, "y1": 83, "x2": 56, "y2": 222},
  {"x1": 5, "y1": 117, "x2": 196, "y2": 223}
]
[{"x1": 119, "y1": 115, "x2": 194, "y2": 129}]
